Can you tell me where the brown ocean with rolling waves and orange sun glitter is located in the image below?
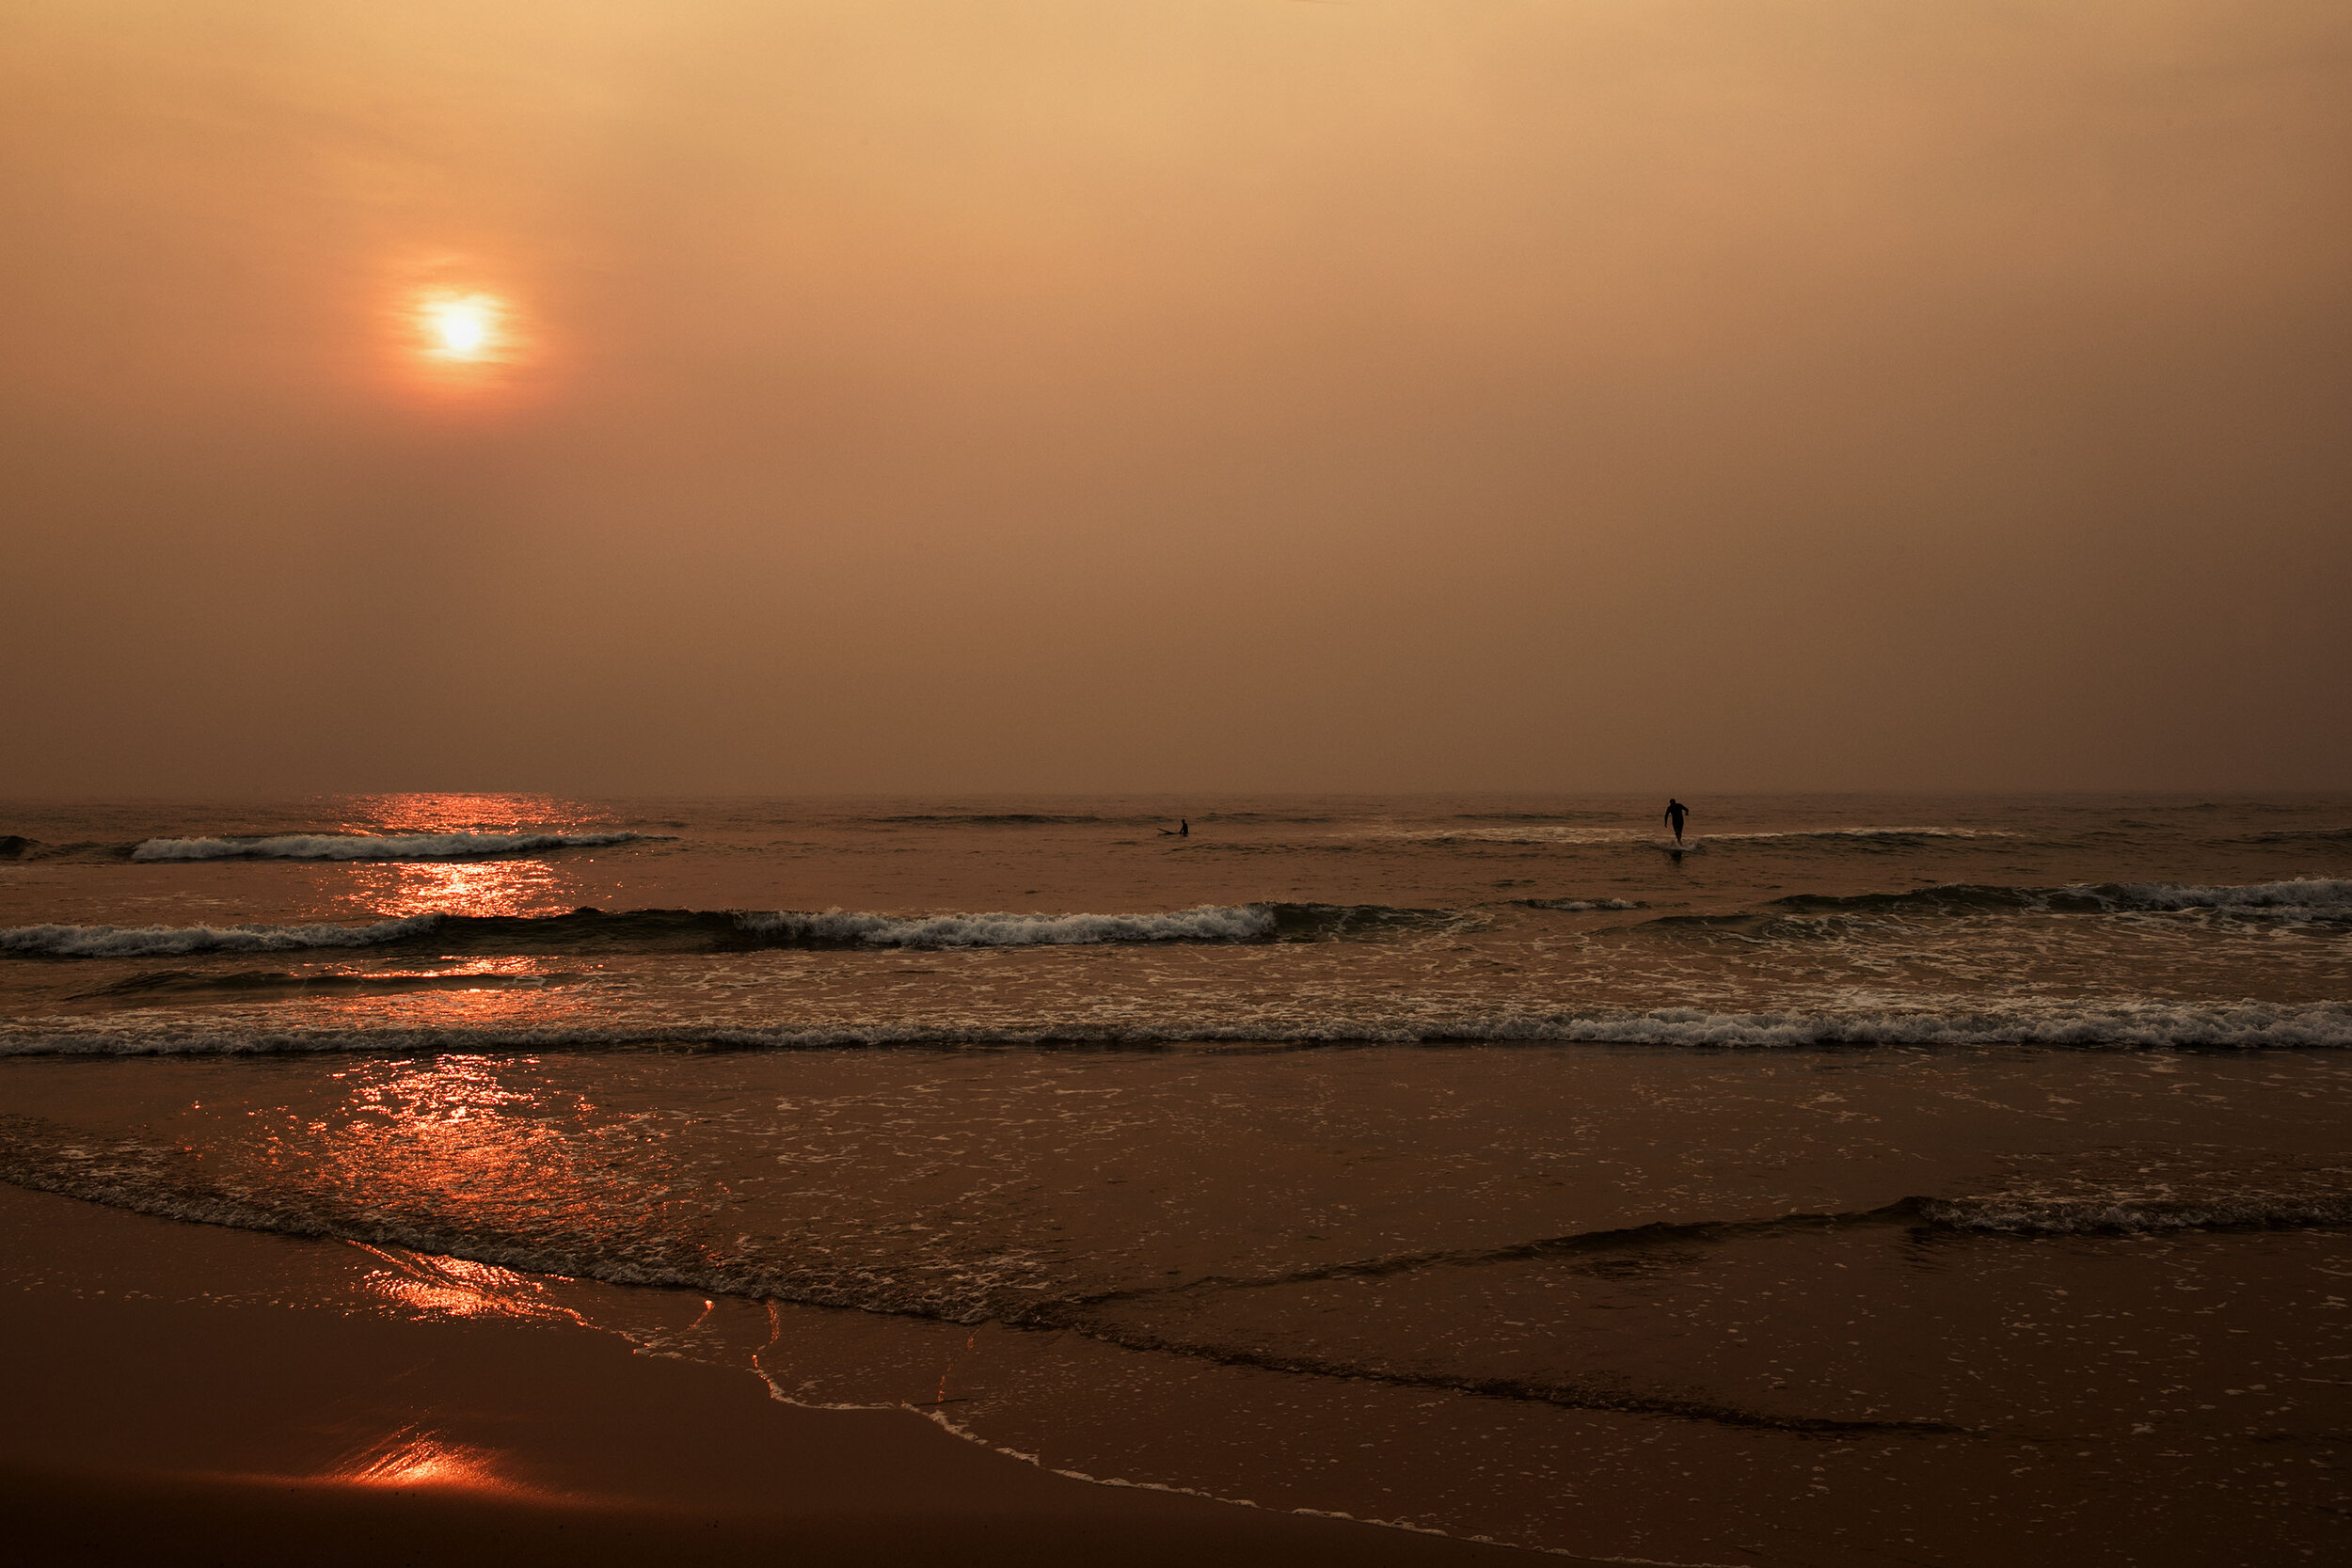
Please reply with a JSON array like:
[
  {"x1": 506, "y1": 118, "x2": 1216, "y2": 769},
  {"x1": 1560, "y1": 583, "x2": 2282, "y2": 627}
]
[{"x1": 0, "y1": 795, "x2": 2352, "y2": 1563}]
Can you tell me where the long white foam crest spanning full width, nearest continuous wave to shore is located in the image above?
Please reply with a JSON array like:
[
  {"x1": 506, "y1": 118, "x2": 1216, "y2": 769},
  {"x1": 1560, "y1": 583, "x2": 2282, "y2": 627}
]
[{"x1": 0, "y1": 1002, "x2": 2352, "y2": 1058}]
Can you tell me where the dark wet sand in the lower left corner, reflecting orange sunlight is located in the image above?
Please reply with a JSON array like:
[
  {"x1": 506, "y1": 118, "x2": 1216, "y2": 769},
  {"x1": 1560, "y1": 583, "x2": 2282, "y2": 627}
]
[{"x1": 0, "y1": 1187, "x2": 1527, "y2": 1568}]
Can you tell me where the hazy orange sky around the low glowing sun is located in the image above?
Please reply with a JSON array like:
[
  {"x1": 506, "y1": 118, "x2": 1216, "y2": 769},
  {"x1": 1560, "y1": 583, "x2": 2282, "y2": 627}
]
[{"x1": 0, "y1": 0, "x2": 2352, "y2": 795}]
